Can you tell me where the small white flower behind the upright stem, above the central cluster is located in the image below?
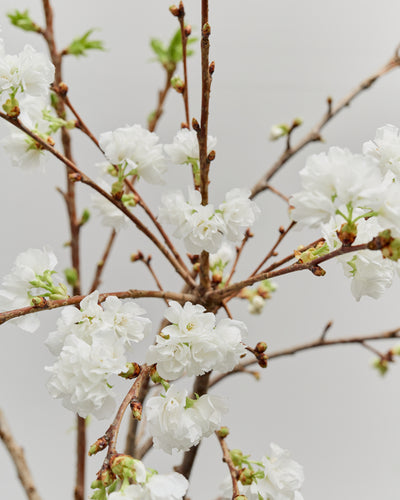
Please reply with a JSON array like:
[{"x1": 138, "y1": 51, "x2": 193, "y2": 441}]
[{"x1": 164, "y1": 128, "x2": 217, "y2": 165}]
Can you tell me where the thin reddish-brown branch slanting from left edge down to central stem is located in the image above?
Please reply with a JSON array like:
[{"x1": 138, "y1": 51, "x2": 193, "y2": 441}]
[{"x1": 0, "y1": 112, "x2": 193, "y2": 288}]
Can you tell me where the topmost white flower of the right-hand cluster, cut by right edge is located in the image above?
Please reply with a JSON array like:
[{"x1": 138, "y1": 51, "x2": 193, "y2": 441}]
[{"x1": 363, "y1": 125, "x2": 400, "y2": 180}]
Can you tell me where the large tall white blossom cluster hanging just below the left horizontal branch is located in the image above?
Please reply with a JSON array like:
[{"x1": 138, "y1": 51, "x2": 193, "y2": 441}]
[{"x1": 46, "y1": 291, "x2": 151, "y2": 418}]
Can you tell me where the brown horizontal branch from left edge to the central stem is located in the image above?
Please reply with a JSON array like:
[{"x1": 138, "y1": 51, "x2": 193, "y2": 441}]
[{"x1": 0, "y1": 289, "x2": 197, "y2": 325}]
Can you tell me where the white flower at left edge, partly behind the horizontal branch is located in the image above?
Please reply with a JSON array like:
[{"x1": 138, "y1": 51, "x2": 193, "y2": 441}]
[{"x1": 0, "y1": 248, "x2": 57, "y2": 332}]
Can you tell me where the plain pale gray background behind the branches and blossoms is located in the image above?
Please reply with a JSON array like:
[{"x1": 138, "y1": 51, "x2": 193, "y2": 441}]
[{"x1": 0, "y1": 0, "x2": 400, "y2": 500}]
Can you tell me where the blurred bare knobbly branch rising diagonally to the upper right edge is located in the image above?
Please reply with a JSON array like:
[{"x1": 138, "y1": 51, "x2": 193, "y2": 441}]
[{"x1": 250, "y1": 49, "x2": 400, "y2": 199}]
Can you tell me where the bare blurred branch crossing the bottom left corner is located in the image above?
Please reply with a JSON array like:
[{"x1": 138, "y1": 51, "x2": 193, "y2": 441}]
[{"x1": 0, "y1": 410, "x2": 41, "y2": 500}]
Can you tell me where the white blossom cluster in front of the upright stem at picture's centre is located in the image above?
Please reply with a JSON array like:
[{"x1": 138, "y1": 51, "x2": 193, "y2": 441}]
[{"x1": 159, "y1": 188, "x2": 259, "y2": 254}]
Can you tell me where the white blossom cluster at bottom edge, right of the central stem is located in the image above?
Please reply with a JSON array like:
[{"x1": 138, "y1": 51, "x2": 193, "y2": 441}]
[{"x1": 221, "y1": 443, "x2": 304, "y2": 500}]
